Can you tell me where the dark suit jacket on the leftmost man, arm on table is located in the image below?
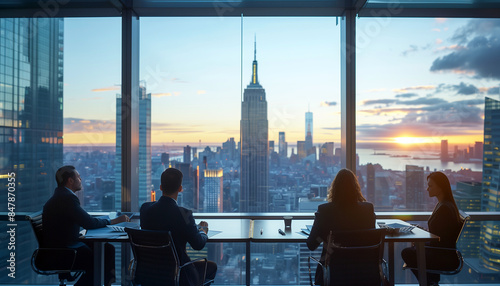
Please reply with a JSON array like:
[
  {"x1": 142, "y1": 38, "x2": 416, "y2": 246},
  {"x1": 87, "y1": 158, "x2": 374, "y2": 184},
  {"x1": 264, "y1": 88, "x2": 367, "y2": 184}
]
[{"x1": 42, "y1": 187, "x2": 109, "y2": 247}]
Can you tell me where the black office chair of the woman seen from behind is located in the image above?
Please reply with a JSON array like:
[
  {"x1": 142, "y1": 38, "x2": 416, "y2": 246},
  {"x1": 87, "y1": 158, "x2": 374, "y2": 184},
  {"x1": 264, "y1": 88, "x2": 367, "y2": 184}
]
[{"x1": 308, "y1": 229, "x2": 387, "y2": 286}]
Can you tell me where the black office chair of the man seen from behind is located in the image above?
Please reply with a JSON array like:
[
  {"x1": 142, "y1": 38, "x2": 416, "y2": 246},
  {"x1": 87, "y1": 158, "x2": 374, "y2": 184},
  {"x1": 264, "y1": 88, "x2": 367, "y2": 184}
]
[{"x1": 125, "y1": 228, "x2": 213, "y2": 286}]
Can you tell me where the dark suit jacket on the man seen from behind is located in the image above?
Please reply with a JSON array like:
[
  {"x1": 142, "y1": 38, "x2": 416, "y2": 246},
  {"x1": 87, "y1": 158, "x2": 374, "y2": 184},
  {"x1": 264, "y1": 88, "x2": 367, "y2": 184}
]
[{"x1": 141, "y1": 196, "x2": 208, "y2": 264}]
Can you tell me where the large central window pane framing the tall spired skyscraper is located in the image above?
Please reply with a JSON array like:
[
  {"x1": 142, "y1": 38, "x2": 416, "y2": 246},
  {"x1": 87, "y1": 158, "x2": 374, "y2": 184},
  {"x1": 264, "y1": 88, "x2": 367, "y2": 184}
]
[{"x1": 140, "y1": 17, "x2": 340, "y2": 212}]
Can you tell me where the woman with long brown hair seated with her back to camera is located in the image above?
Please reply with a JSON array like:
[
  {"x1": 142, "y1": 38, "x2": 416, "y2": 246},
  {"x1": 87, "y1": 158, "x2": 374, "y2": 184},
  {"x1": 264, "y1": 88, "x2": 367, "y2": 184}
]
[{"x1": 307, "y1": 169, "x2": 375, "y2": 285}]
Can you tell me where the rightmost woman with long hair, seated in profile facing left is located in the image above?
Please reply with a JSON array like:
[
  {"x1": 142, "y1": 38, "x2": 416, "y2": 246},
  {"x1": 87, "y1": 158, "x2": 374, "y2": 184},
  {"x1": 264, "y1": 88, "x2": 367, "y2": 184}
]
[{"x1": 401, "y1": 172, "x2": 462, "y2": 285}]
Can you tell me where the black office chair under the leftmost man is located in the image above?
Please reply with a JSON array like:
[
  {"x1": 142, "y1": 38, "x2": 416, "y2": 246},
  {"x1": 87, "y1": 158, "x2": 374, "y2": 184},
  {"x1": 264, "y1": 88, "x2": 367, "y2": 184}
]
[{"x1": 26, "y1": 211, "x2": 84, "y2": 285}]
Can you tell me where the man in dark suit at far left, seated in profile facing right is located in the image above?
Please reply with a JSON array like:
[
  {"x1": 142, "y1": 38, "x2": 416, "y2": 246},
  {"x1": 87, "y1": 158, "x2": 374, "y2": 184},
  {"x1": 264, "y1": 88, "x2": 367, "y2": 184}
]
[{"x1": 41, "y1": 166, "x2": 129, "y2": 286}]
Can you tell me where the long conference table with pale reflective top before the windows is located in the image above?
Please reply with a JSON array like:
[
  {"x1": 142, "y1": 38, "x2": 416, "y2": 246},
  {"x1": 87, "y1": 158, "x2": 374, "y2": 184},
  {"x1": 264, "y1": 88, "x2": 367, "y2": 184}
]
[{"x1": 81, "y1": 219, "x2": 439, "y2": 285}]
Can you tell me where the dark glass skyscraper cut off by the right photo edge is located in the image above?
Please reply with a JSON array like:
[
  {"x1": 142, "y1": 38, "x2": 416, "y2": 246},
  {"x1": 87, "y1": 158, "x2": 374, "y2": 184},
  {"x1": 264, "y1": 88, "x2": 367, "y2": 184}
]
[{"x1": 479, "y1": 97, "x2": 500, "y2": 271}]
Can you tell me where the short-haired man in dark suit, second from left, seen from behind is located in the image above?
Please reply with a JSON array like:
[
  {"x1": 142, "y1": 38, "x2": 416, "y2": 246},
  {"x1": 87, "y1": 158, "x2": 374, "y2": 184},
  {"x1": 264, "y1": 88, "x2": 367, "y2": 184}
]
[{"x1": 141, "y1": 168, "x2": 217, "y2": 285}]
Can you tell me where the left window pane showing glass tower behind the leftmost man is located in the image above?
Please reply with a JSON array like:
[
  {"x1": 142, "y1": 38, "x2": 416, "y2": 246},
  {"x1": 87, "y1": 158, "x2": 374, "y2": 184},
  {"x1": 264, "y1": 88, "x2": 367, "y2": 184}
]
[{"x1": 0, "y1": 18, "x2": 121, "y2": 284}]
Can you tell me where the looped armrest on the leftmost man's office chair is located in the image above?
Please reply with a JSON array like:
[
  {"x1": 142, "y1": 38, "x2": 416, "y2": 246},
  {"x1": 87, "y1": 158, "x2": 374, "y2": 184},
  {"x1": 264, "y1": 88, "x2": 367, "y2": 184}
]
[{"x1": 31, "y1": 248, "x2": 76, "y2": 274}]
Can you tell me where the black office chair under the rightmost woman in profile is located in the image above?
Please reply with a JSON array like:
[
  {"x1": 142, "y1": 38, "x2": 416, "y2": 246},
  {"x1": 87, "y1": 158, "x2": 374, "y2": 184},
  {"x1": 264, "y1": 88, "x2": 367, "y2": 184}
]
[{"x1": 403, "y1": 211, "x2": 470, "y2": 275}]
